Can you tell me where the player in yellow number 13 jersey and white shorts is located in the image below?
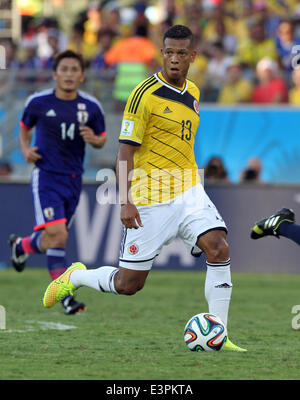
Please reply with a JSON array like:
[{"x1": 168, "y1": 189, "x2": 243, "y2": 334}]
[{"x1": 43, "y1": 25, "x2": 245, "y2": 351}]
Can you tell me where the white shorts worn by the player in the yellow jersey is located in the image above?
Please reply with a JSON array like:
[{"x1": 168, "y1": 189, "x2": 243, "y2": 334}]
[{"x1": 119, "y1": 184, "x2": 227, "y2": 271}]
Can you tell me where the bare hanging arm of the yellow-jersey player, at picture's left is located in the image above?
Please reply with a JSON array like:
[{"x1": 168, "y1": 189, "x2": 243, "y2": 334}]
[{"x1": 117, "y1": 143, "x2": 143, "y2": 229}]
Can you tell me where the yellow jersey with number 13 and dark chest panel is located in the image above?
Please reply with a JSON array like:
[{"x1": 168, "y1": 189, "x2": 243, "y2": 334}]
[{"x1": 119, "y1": 72, "x2": 200, "y2": 205}]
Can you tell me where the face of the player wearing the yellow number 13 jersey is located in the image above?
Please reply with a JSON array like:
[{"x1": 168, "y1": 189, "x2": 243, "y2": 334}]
[{"x1": 161, "y1": 38, "x2": 196, "y2": 86}]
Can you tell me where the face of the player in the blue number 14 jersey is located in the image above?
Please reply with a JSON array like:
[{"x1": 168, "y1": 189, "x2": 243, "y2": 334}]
[{"x1": 53, "y1": 58, "x2": 84, "y2": 92}]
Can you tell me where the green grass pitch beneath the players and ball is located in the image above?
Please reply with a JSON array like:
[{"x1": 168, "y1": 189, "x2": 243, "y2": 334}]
[{"x1": 0, "y1": 268, "x2": 300, "y2": 380}]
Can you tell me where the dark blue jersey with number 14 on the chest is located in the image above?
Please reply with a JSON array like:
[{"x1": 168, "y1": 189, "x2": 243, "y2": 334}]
[{"x1": 20, "y1": 89, "x2": 106, "y2": 175}]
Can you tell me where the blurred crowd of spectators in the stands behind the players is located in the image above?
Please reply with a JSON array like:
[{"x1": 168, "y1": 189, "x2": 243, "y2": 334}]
[{"x1": 0, "y1": 0, "x2": 300, "y2": 106}]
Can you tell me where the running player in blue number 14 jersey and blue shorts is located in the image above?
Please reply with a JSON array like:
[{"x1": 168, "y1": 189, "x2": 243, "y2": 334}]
[{"x1": 9, "y1": 50, "x2": 106, "y2": 314}]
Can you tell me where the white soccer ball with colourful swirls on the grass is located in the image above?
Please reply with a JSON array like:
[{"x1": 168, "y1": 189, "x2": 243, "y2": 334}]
[{"x1": 184, "y1": 313, "x2": 227, "y2": 351}]
